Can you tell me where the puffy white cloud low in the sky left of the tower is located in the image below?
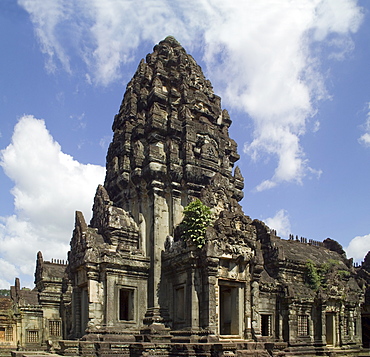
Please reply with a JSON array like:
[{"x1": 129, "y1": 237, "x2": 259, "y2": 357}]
[{"x1": 0, "y1": 115, "x2": 105, "y2": 287}]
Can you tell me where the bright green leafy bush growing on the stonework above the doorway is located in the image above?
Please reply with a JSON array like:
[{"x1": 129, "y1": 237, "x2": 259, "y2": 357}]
[{"x1": 180, "y1": 199, "x2": 212, "y2": 248}]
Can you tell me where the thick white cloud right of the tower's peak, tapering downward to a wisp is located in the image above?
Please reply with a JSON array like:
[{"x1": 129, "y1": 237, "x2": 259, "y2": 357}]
[{"x1": 199, "y1": 1, "x2": 361, "y2": 190}]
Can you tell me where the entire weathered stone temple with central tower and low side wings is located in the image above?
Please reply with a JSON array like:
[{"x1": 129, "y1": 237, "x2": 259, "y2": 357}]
[{"x1": 0, "y1": 37, "x2": 370, "y2": 357}]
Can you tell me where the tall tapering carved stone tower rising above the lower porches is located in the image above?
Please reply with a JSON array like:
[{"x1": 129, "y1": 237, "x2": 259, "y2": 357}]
[{"x1": 98, "y1": 37, "x2": 243, "y2": 321}]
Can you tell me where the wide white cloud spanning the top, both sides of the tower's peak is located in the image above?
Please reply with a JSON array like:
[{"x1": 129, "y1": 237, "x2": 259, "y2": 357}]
[{"x1": 18, "y1": 0, "x2": 364, "y2": 191}]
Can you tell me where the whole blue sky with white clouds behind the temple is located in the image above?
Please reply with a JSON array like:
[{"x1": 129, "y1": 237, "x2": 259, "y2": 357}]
[{"x1": 0, "y1": 0, "x2": 370, "y2": 288}]
